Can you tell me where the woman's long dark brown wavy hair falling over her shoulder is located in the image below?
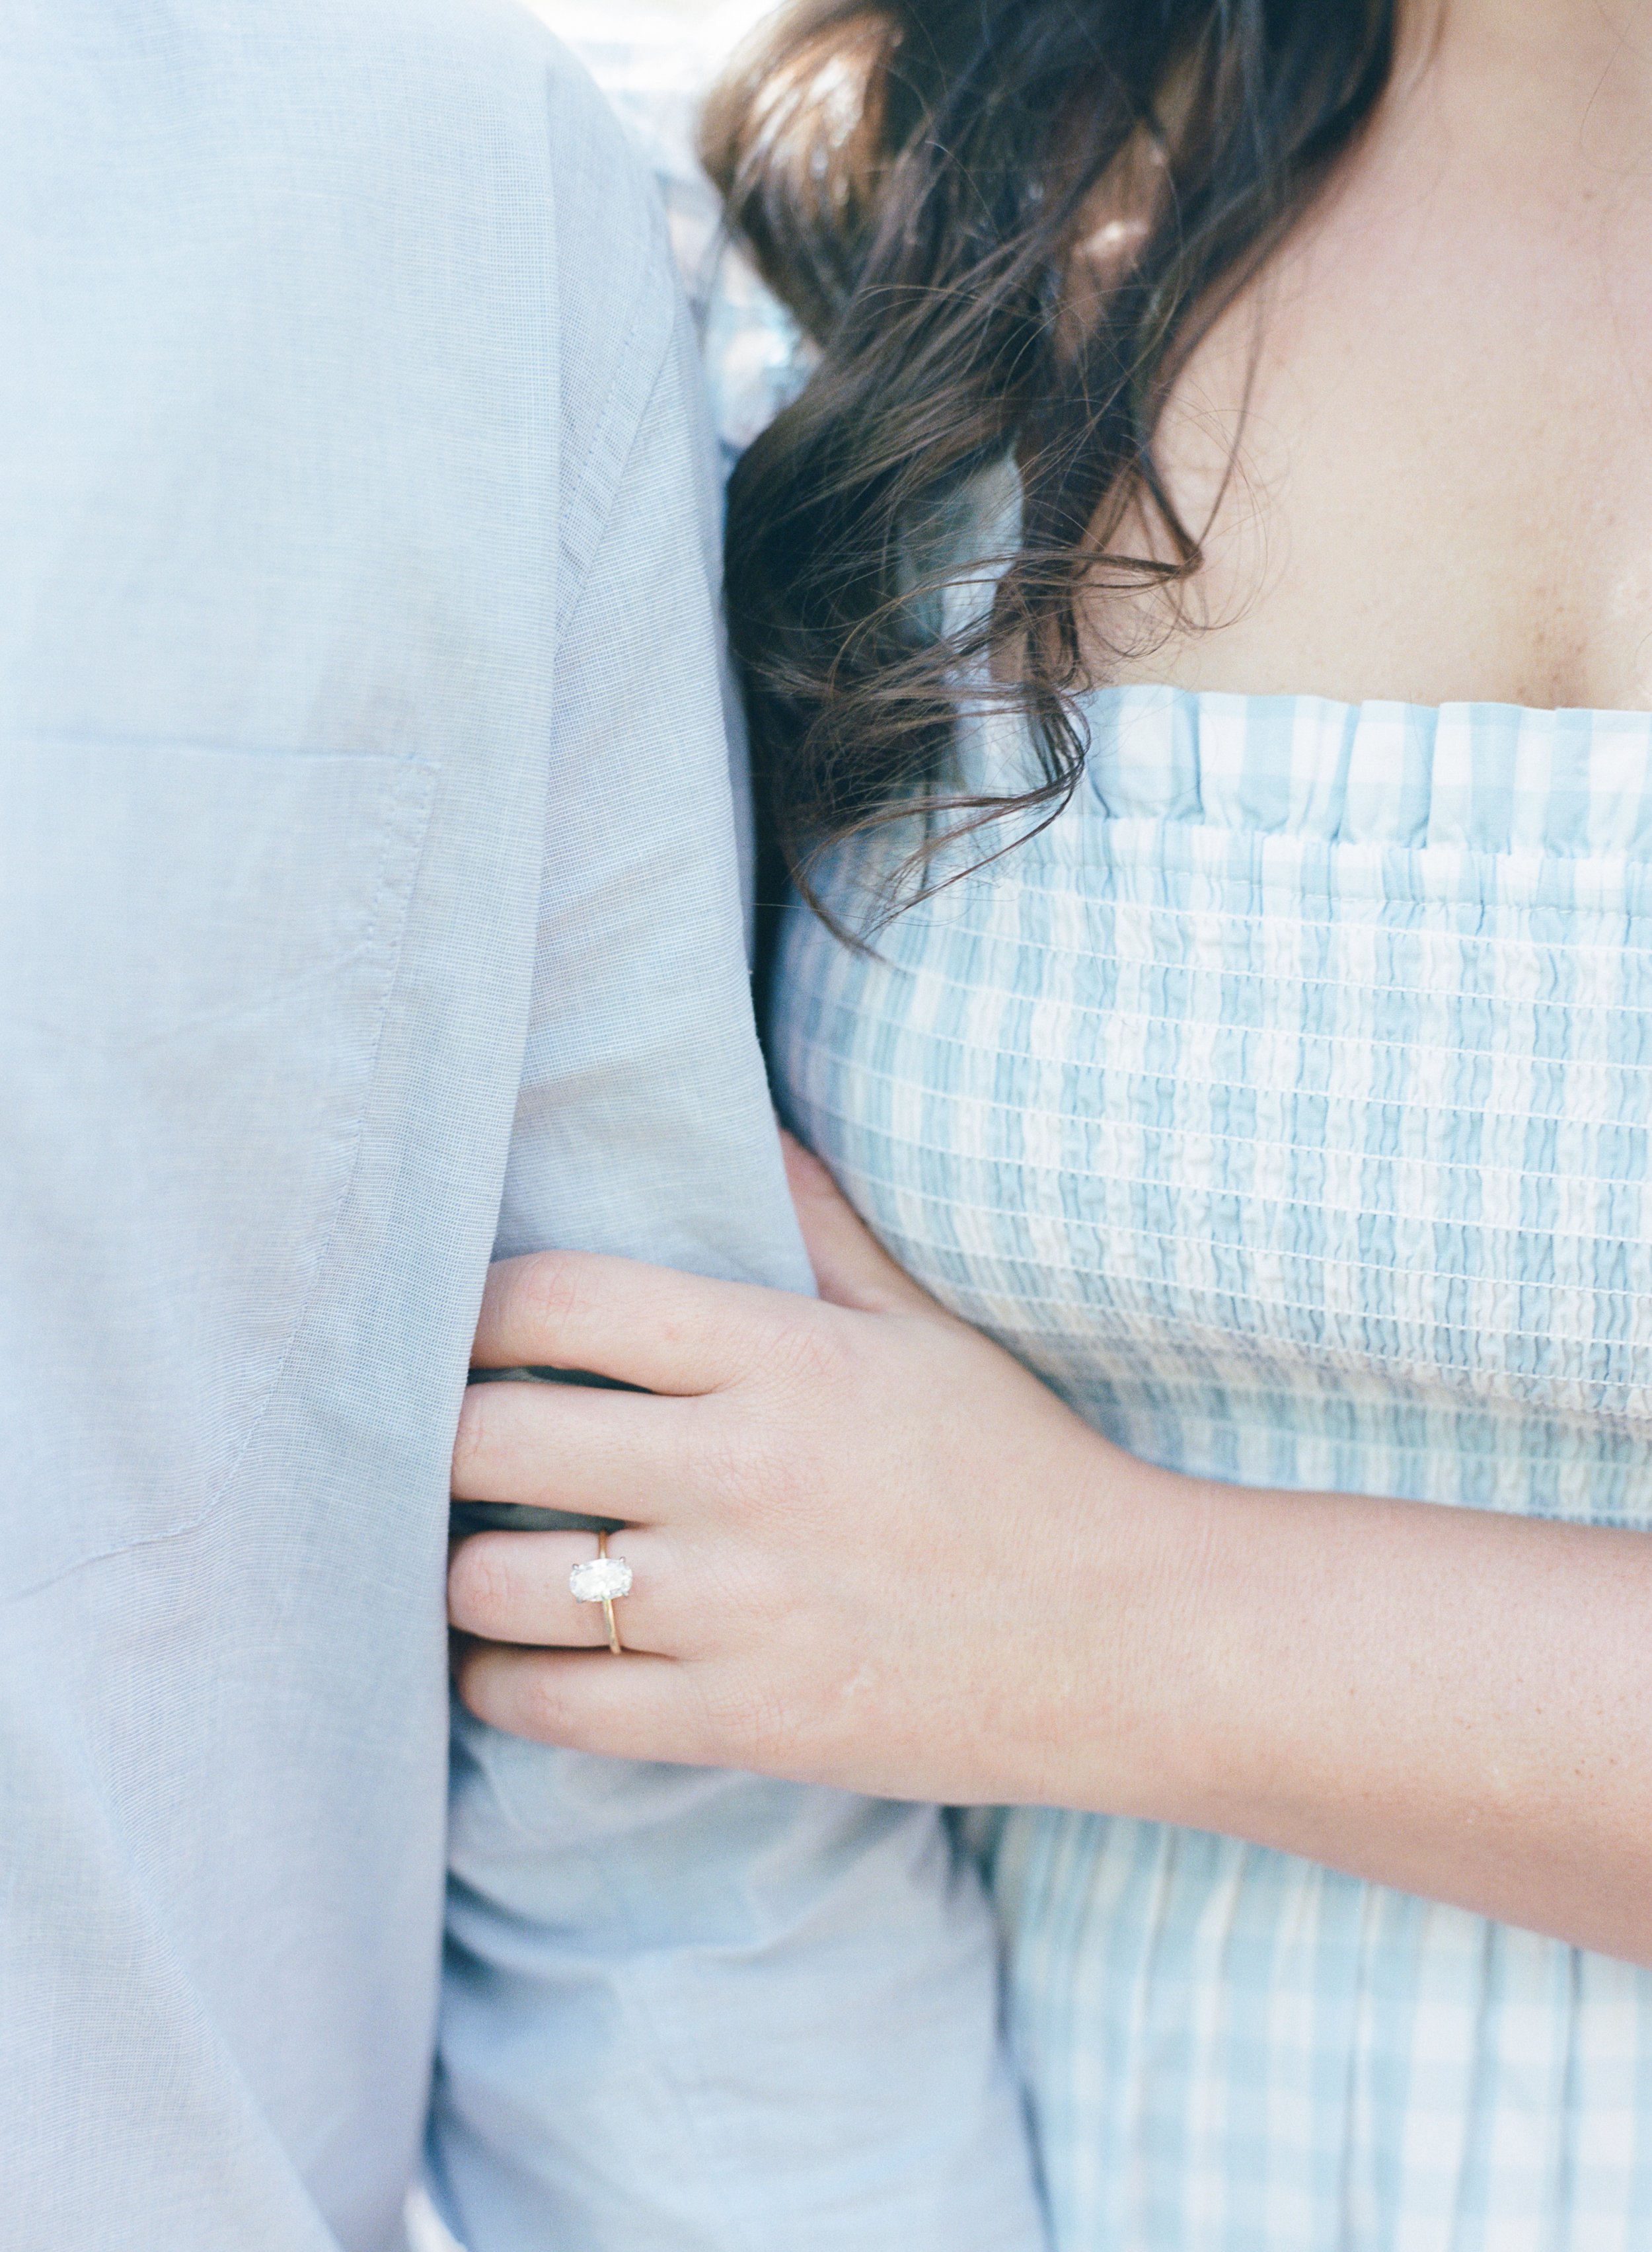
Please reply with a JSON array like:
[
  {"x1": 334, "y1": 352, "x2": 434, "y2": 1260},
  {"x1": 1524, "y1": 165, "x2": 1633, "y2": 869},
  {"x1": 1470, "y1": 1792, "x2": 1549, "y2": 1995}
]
[{"x1": 702, "y1": 0, "x2": 1396, "y2": 908}]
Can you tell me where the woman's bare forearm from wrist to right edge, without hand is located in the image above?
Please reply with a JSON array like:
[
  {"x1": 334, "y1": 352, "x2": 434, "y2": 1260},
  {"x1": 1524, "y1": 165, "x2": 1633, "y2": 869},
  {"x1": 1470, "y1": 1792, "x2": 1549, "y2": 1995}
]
[{"x1": 1080, "y1": 1450, "x2": 1652, "y2": 1961}]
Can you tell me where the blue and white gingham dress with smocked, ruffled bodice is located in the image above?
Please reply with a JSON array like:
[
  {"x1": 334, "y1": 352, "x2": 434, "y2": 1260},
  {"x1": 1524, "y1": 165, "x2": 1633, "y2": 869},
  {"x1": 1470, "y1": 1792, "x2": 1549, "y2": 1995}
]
[{"x1": 774, "y1": 687, "x2": 1652, "y2": 2252}]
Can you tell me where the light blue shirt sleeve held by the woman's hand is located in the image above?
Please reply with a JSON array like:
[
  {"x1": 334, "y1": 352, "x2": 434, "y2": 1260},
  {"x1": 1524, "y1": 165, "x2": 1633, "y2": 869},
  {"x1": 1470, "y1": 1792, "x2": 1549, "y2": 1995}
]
[{"x1": 430, "y1": 65, "x2": 1042, "y2": 2252}]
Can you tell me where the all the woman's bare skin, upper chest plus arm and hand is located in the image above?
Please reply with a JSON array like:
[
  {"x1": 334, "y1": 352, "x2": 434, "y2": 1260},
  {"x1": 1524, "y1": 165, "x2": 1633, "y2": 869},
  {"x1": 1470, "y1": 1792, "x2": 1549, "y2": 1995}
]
[{"x1": 450, "y1": 0, "x2": 1652, "y2": 1964}]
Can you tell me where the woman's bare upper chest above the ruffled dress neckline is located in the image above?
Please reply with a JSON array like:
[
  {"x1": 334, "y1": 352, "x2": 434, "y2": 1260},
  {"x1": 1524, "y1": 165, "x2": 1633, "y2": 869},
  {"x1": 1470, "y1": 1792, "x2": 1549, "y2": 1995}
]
[{"x1": 1096, "y1": 0, "x2": 1652, "y2": 709}]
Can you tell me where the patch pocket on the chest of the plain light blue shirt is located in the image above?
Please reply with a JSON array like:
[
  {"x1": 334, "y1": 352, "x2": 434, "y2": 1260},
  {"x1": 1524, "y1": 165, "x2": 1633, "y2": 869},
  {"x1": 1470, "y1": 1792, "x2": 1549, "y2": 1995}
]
[{"x1": 0, "y1": 738, "x2": 437, "y2": 1594}]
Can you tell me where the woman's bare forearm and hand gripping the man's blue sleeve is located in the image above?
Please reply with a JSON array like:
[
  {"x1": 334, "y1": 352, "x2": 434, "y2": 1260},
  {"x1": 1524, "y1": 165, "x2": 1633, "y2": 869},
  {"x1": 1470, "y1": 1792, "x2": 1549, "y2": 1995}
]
[{"x1": 453, "y1": 1135, "x2": 1652, "y2": 1964}]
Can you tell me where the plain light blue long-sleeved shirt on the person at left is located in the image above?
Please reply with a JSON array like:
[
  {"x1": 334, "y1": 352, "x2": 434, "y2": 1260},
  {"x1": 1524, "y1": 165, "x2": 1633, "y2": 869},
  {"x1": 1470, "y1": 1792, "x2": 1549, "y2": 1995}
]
[{"x1": 0, "y1": 0, "x2": 1037, "y2": 2252}]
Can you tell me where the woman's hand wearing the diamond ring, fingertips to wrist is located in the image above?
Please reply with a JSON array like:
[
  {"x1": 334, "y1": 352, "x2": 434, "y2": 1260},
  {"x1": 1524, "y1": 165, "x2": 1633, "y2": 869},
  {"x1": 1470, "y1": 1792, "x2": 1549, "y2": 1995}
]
[{"x1": 450, "y1": 1146, "x2": 1154, "y2": 1799}]
